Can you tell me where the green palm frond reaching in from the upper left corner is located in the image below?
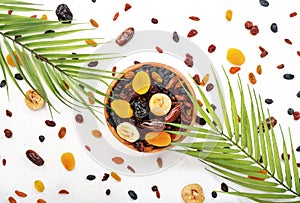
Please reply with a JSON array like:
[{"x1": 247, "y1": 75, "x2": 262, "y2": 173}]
[{"x1": 0, "y1": 0, "x2": 116, "y2": 121}]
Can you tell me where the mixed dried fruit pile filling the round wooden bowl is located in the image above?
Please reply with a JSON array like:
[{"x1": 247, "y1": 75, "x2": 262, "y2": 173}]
[{"x1": 106, "y1": 64, "x2": 194, "y2": 152}]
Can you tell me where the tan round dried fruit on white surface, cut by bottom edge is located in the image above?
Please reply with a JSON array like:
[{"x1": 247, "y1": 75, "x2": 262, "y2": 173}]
[{"x1": 181, "y1": 183, "x2": 205, "y2": 203}]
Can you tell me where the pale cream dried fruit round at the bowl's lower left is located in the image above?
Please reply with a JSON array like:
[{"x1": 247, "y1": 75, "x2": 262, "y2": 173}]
[{"x1": 117, "y1": 122, "x2": 140, "y2": 142}]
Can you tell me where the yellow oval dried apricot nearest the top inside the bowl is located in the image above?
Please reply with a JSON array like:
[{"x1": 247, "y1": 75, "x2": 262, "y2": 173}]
[{"x1": 132, "y1": 71, "x2": 151, "y2": 94}]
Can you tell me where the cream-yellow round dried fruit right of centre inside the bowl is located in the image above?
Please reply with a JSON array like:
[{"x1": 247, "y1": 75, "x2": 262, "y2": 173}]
[{"x1": 149, "y1": 93, "x2": 172, "y2": 116}]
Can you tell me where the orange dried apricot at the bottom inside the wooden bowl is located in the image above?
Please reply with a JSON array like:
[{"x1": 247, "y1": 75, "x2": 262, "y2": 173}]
[{"x1": 145, "y1": 132, "x2": 171, "y2": 147}]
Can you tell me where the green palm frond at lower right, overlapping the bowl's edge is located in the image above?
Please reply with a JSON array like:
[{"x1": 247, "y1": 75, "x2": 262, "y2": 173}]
[{"x1": 171, "y1": 66, "x2": 300, "y2": 202}]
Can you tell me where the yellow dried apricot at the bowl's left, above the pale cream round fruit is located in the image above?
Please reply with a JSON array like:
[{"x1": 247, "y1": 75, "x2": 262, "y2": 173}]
[{"x1": 110, "y1": 99, "x2": 133, "y2": 118}]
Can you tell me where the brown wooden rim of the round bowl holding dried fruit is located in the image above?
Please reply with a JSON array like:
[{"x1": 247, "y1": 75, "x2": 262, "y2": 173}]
[{"x1": 104, "y1": 62, "x2": 197, "y2": 153}]
